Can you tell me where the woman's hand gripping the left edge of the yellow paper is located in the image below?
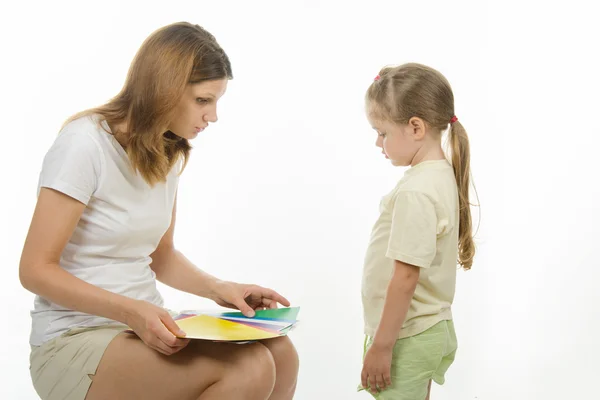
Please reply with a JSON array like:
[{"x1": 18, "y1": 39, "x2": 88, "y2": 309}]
[{"x1": 126, "y1": 300, "x2": 190, "y2": 355}]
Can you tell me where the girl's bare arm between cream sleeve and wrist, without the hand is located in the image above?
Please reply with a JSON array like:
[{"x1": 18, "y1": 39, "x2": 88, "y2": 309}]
[{"x1": 372, "y1": 260, "x2": 420, "y2": 350}]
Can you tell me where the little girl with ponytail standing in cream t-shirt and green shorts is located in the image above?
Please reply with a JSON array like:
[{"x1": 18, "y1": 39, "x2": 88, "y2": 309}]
[{"x1": 359, "y1": 64, "x2": 475, "y2": 400}]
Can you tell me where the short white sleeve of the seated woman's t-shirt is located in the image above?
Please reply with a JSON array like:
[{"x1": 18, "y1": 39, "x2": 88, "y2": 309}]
[{"x1": 38, "y1": 131, "x2": 102, "y2": 205}]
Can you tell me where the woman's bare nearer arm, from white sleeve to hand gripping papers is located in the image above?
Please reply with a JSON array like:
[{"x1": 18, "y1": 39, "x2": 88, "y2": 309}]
[{"x1": 19, "y1": 188, "x2": 187, "y2": 354}]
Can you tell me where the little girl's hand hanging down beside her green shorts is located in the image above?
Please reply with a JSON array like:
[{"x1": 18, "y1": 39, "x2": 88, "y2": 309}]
[{"x1": 361, "y1": 344, "x2": 392, "y2": 394}]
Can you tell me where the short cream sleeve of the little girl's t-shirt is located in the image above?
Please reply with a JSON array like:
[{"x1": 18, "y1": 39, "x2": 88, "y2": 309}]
[{"x1": 386, "y1": 191, "x2": 437, "y2": 268}]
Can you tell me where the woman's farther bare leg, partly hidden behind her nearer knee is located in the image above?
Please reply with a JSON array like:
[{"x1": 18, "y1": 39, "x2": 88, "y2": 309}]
[{"x1": 261, "y1": 336, "x2": 299, "y2": 400}]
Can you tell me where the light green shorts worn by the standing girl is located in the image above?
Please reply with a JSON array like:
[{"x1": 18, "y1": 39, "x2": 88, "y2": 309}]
[{"x1": 358, "y1": 320, "x2": 458, "y2": 400}]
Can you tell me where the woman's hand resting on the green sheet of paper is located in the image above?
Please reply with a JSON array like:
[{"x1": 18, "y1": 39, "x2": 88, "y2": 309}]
[{"x1": 211, "y1": 281, "x2": 290, "y2": 317}]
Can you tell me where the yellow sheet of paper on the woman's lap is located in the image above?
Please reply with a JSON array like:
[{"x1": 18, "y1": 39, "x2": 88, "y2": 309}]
[{"x1": 175, "y1": 315, "x2": 281, "y2": 341}]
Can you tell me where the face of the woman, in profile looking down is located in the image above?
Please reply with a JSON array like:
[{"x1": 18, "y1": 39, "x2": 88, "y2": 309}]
[{"x1": 169, "y1": 79, "x2": 228, "y2": 139}]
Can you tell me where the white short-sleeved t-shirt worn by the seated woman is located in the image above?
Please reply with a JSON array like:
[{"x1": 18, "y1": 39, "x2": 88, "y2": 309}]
[{"x1": 30, "y1": 116, "x2": 179, "y2": 345}]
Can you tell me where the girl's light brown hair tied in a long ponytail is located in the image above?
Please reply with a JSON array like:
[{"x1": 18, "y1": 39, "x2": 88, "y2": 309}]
[{"x1": 366, "y1": 63, "x2": 475, "y2": 270}]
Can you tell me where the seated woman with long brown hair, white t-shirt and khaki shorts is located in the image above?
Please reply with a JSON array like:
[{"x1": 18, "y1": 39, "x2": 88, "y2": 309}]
[{"x1": 20, "y1": 23, "x2": 298, "y2": 400}]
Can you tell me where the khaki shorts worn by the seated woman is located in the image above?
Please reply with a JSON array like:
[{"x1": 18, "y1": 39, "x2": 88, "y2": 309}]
[{"x1": 29, "y1": 325, "x2": 127, "y2": 400}]
